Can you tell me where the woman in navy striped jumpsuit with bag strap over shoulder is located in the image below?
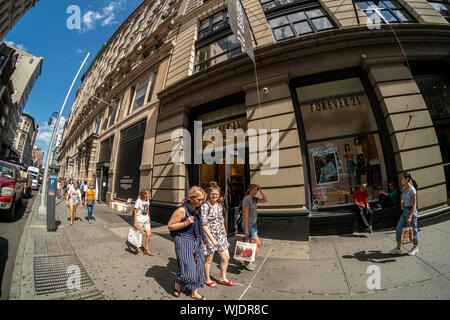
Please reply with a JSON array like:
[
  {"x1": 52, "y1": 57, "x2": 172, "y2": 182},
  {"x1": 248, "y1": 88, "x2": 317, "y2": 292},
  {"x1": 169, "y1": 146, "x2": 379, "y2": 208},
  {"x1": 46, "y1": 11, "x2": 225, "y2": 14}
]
[{"x1": 168, "y1": 186, "x2": 206, "y2": 300}]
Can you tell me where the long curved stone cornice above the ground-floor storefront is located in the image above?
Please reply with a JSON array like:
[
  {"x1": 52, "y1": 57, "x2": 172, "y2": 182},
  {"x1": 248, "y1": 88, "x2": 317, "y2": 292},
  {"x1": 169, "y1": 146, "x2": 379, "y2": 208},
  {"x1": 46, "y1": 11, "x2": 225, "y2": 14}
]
[{"x1": 158, "y1": 24, "x2": 450, "y2": 104}]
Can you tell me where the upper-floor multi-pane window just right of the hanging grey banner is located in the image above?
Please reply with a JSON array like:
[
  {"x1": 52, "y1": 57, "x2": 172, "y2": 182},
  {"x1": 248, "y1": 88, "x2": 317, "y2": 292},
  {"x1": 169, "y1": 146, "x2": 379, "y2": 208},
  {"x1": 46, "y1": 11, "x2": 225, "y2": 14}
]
[{"x1": 260, "y1": 0, "x2": 336, "y2": 41}]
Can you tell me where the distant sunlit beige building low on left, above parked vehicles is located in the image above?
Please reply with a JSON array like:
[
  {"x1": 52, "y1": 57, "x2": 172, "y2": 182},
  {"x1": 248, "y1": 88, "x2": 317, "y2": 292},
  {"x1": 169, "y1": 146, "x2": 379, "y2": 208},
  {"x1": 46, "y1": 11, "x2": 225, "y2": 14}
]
[{"x1": 14, "y1": 112, "x2": 39, "y2": 166}]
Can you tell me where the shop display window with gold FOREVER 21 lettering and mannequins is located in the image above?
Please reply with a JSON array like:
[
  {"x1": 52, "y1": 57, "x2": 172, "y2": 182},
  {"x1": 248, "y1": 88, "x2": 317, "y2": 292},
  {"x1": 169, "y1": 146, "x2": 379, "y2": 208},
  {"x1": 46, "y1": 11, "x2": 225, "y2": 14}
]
[{"x1": 296, "y1": 78, "x2": 388, "y2": 210}]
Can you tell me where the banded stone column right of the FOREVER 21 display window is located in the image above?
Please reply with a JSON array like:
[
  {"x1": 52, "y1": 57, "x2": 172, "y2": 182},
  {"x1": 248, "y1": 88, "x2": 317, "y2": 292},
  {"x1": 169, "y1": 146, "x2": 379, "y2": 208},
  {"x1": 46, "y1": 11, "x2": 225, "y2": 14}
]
[{"x1": 362, "y1": 57, "x2": 447, "y2": 212}]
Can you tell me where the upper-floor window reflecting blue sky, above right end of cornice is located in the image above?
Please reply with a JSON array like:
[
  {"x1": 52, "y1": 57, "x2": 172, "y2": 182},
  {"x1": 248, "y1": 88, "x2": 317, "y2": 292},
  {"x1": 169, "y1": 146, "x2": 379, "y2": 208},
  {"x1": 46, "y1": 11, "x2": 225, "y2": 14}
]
[{"x1": 356, "y1": 0, "x2": 416, "y2": 24}]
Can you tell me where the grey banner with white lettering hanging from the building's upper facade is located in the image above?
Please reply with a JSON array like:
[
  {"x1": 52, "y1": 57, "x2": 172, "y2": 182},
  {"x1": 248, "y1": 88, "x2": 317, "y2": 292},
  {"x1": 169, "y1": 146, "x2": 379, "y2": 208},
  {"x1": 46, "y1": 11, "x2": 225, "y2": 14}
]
[{"x1": 228, "y1": 0, "x2": 255, "y2": 62}]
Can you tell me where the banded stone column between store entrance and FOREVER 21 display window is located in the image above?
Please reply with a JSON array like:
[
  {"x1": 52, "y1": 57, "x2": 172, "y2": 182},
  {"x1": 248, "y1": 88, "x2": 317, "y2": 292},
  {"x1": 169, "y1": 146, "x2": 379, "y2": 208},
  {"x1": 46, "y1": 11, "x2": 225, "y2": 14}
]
[{"x1": 243, "y1": 74, "x2": 309, "y2": 241}]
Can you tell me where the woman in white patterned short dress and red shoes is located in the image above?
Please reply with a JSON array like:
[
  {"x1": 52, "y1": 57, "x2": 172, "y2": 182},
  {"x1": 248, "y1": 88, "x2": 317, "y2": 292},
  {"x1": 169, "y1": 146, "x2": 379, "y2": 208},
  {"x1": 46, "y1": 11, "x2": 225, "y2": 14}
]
[{"x1": 201, "y1": 183, "x2": 234, "y2": 288}]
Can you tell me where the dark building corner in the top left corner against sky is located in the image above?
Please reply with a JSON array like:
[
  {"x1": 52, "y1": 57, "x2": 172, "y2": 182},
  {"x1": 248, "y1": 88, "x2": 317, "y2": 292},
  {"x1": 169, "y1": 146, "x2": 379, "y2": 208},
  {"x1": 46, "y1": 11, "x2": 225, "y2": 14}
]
[{"x1": 0, "y1": 0, "x2": 39, "y2": 41}]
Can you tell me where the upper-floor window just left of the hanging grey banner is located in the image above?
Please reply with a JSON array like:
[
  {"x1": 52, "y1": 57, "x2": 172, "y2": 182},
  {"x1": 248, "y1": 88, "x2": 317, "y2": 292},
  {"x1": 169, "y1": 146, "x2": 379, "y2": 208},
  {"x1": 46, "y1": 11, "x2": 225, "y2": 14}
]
[{"x1": 195, "y1": 10, "x2": 242, "y2": 72}]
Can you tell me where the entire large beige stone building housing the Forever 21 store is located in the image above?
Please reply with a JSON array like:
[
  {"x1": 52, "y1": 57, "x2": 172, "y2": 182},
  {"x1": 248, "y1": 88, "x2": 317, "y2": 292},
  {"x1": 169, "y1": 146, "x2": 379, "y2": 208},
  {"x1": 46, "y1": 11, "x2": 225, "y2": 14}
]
[{"x1": 59, "y1": 0, "x2": 450, "y2": 240}]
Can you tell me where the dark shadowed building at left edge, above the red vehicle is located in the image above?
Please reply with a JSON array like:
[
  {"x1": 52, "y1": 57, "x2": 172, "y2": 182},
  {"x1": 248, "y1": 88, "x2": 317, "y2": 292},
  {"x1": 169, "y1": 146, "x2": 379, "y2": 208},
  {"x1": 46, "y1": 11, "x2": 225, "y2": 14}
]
[{"x1": 0, "y1": 43, "x2": 17, "y2": 159}]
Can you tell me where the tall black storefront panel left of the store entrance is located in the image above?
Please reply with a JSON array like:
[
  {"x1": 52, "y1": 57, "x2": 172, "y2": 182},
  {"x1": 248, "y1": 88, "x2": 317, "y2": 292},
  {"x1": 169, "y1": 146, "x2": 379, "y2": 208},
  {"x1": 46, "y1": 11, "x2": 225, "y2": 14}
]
[{"x1": 115, "y1": 121, "x2": 146, "y2": 200}]
